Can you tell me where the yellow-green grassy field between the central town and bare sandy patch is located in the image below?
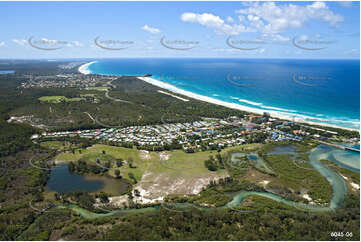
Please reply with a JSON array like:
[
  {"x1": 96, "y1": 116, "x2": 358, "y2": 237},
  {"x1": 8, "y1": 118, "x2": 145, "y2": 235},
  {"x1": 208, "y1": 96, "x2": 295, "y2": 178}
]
[{"x1": 53, "y1": 144, "x2": 226, "y2": 189}]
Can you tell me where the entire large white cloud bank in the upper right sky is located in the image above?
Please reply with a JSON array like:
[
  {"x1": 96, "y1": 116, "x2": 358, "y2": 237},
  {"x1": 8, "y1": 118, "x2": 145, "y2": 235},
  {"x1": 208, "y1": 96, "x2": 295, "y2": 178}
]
[{"x1": 181, "y1": 2, "x2": 344, "y2": 36}]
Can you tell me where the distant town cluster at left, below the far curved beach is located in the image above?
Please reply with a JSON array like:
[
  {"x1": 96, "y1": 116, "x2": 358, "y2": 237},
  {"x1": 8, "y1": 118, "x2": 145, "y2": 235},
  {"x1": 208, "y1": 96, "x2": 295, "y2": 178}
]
[{"x1": 20, "y1": 74, "x2": 116, "y2": 88}]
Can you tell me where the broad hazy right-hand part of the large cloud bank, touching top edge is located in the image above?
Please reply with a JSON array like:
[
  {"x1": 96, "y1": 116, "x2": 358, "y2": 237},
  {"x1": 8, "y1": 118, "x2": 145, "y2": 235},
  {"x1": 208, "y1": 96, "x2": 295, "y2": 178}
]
[{"x1": 236, "y1": 2, "x2": 343, "y2": 33}]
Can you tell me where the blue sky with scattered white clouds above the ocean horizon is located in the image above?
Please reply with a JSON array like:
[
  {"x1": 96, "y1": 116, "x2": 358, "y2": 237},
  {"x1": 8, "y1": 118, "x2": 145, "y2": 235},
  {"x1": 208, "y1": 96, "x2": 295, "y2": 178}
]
[{"x1": 0, "y1": 2, "x2": 360, "y2": 59}]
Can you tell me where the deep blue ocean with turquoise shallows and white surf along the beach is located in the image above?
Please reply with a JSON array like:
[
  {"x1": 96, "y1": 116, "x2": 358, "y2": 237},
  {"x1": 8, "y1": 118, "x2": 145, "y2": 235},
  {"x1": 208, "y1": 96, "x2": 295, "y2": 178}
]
[{"x1": 88, "y1": 58, "x2": 360, "y2": 129}]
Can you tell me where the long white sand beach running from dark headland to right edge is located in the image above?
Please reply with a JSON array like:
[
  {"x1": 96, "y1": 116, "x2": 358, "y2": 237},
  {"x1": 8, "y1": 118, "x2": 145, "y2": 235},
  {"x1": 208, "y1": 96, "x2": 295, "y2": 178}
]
[{"x1": 137, "y1": 77, "x2": 359, "y2": 131}]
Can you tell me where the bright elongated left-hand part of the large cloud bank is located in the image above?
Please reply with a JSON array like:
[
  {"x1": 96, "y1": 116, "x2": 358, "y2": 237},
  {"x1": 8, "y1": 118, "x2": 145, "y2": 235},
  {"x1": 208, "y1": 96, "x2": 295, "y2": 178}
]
[{"x1": 181, "y1": 12, "x2": 253, "y2": 35}]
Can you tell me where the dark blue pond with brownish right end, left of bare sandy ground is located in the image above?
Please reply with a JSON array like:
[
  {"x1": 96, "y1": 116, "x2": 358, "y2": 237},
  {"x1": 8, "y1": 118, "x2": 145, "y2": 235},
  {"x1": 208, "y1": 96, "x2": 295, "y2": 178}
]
[{"x1": 46, "y1": 164, "x2": 129, "y2": 196}]
